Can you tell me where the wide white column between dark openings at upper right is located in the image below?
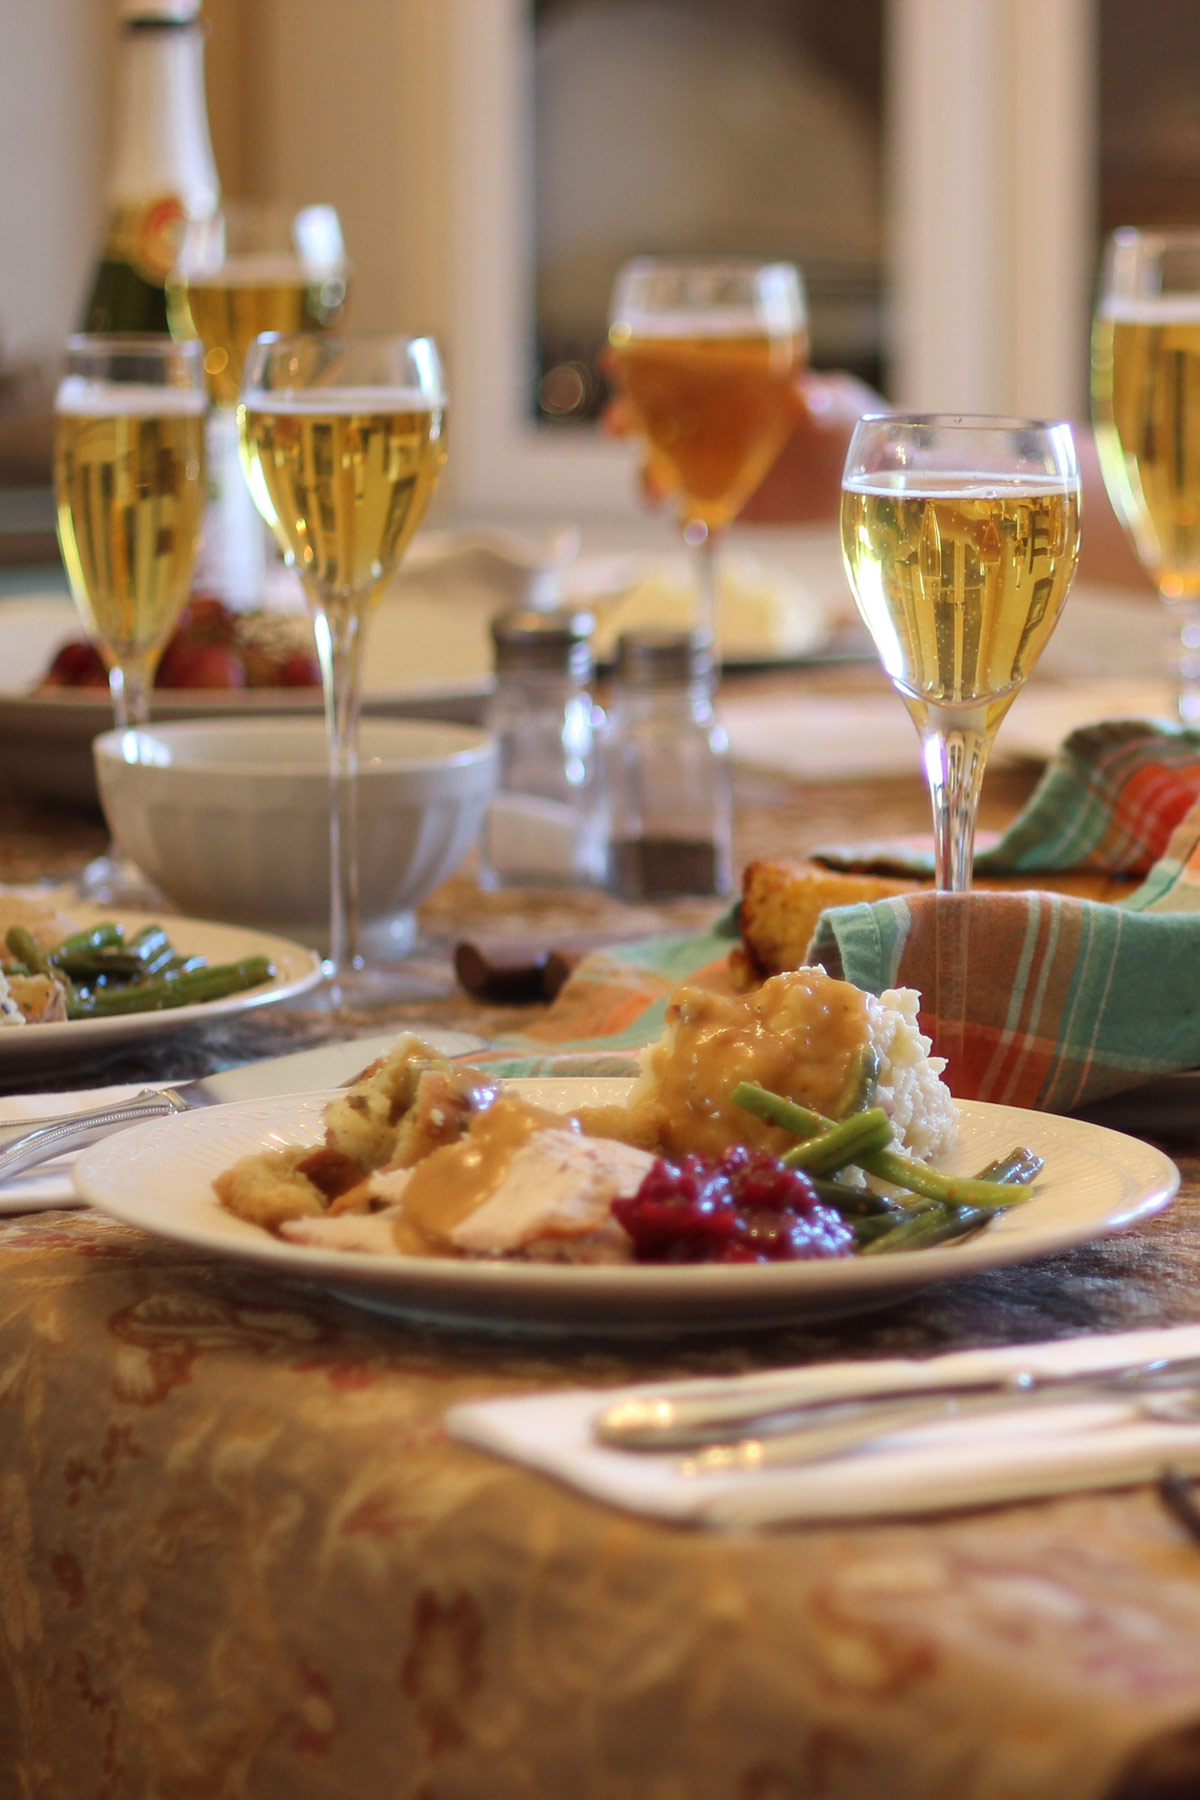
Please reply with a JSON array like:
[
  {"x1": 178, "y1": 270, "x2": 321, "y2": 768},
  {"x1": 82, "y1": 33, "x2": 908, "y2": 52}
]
[{"x1": 889, "y1": 0, "x2": 1096, "y2": 416}]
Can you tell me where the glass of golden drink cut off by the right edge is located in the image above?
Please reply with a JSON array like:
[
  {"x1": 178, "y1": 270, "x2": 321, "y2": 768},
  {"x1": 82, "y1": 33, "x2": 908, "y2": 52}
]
[{"x1": 1092, "y1": 227, "x2": 1200, "y2": 725}]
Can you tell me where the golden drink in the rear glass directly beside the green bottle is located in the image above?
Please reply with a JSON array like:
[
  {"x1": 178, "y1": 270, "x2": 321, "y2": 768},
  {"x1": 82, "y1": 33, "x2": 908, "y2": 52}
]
[{"x1": 167, "y1": 265, "x2": 354, "y2": 407}]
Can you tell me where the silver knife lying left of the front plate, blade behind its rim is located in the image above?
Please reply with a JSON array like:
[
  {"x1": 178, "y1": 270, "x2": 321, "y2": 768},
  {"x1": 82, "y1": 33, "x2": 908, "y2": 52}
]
[{"x1": 0, "y1": 1026, "x2": 484, "y2": 1181}]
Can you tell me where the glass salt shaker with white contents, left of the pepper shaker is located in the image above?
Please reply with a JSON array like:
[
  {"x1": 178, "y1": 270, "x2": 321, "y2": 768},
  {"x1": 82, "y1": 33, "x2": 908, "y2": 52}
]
[{"x1": 482, "y1": 610, "x2": 604, "y2": 887}]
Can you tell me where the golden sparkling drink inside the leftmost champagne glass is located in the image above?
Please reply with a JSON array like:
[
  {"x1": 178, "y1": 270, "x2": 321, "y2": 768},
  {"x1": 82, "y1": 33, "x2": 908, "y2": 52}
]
[{"x1": 54, "y1": 391, "x2": 205, "y2": 662}]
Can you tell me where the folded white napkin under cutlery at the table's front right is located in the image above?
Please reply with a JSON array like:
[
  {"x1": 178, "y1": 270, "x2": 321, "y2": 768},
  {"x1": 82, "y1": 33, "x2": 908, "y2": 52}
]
[{"x1": 446, "y1": 1325, "x2": 1200, "y2": 1526}]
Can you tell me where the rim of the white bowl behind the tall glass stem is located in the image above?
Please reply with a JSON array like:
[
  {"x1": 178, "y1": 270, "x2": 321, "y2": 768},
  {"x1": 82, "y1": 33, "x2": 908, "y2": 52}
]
[{"x1": 92, "y1": 718, "x2": 497, "y2": 781}]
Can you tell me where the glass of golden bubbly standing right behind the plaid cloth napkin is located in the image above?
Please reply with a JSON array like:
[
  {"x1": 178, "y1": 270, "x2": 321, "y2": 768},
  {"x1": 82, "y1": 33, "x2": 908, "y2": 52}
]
[{"x1": 842, "y1": 414, "x2": 1079, "y2": 1067}]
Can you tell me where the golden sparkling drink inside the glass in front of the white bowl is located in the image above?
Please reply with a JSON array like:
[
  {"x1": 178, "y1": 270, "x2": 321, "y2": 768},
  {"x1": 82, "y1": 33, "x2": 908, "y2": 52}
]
[{"x1": 239, "y1": 389, "x2": 446, "y2": 610}]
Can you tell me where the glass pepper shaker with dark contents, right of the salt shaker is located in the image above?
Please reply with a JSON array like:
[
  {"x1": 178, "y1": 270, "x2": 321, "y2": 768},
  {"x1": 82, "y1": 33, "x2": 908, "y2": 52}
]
[{"x1": 604, "y1": 630, "x2": 734, "y2": 900}]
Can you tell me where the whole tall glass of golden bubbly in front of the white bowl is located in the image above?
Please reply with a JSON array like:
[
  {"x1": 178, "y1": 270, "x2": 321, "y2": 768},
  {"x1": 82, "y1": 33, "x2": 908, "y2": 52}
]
[{"x1": 237, "y1": 333, "x2": 446, "y2": 1006}]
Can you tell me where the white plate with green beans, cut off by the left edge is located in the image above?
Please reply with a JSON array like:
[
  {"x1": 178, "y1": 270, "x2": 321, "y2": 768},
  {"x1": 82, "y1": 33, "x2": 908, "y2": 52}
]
[{"x1": 0, "y1": 900, "x2": 320, "y2": 1076}]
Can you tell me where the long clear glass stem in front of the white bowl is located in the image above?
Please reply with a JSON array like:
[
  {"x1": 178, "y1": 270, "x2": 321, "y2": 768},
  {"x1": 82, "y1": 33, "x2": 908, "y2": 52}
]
[{"x1": 313, "y1": 594, "x2": 365, "y2": 985}]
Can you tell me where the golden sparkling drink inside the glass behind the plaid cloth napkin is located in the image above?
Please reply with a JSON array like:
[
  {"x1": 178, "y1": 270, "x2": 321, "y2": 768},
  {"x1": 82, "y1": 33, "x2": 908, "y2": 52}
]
[{"x1": 842, "y1": 475, "x2": 1079, "y2": 733}]
